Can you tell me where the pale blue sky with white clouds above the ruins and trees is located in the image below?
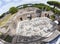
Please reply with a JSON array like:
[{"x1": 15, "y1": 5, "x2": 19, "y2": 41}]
[{"x1": 0, "y1": 0, "x2": 59, "y2": 15}]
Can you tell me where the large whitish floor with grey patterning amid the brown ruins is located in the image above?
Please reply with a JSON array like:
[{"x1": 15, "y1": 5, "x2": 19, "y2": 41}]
[{"x1": 16, "y1": 17, "x2": 53, "y2": 36}]
